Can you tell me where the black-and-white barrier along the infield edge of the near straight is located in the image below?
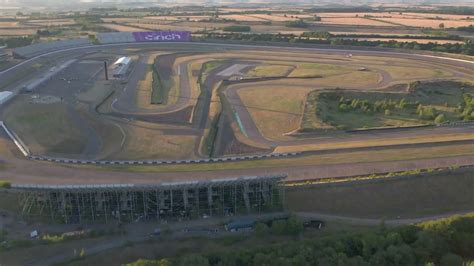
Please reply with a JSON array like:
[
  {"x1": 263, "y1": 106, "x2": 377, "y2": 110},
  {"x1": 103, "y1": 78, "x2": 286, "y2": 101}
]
[{"x1": 26, "y1": 152, "x2": 303, "y2": 165}]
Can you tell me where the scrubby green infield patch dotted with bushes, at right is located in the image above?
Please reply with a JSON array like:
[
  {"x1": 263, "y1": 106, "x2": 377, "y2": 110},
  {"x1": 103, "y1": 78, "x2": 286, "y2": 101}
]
[{"x1": 302, "y1": 81, "x2": 474, "y2": 130}]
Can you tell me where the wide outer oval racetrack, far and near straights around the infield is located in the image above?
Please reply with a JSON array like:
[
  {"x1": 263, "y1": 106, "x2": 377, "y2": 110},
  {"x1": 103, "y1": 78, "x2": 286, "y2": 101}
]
[{"x1": 0, "y1": 43, "x2": 474, "y2": 184}]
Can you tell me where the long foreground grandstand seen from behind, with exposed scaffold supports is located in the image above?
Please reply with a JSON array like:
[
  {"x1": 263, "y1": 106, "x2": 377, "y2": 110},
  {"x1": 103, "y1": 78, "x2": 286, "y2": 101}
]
[{"x1": 13, "y1": 175, "x2": 287, "y2": 224}]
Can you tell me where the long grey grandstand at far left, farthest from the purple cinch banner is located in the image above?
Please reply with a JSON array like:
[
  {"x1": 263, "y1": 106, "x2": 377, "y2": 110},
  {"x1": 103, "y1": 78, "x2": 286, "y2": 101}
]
[{"x1": 13, "y1": 39, "x2": 92, "y2": 59}]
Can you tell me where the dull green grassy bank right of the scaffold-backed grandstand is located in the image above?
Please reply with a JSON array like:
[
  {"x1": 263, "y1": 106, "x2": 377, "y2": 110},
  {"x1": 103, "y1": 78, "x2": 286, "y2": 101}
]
[{"x1": 286, "y1": 168, "x2": 474, "y2": 219}]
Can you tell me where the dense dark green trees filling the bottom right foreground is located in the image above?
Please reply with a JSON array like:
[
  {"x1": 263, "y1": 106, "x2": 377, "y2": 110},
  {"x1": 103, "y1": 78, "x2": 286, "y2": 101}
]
[{"x1": 129, "y1": 215, "x2": 474, "y2": 266}]
